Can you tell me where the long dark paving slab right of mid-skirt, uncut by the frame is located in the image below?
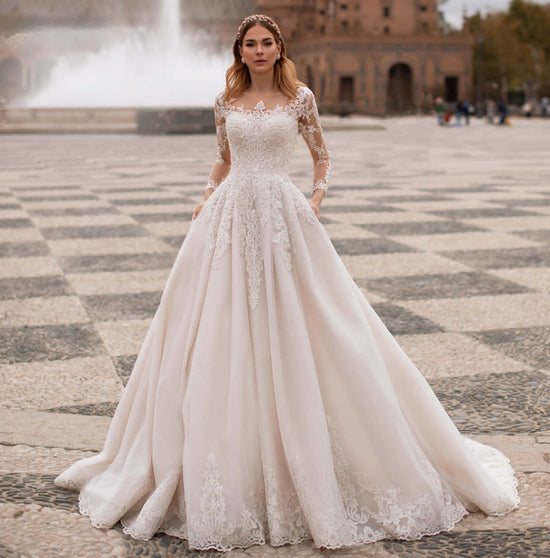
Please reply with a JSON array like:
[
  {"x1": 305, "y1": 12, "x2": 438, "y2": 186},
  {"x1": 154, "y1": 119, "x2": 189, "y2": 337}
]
[{"x1": 365, "y1": 272, "x2": 530, "y2": 300}]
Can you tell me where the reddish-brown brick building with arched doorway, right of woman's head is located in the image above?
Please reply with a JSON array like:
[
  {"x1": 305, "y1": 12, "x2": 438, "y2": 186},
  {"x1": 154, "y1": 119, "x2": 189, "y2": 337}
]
[{"x1": 258, "y1": 0, "x2": 472, "y2": 115}]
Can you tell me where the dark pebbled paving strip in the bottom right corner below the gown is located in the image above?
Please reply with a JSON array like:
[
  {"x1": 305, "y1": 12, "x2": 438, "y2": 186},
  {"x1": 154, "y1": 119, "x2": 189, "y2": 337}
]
[{"x1": 383, "y1": 527, "x2": 550, "y2": 558}]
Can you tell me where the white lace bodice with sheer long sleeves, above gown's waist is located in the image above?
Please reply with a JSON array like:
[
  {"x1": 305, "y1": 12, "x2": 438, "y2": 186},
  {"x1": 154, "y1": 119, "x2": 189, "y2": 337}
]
[{"x1": 207, "y1": 87, "x2": 331, "y2": 194}]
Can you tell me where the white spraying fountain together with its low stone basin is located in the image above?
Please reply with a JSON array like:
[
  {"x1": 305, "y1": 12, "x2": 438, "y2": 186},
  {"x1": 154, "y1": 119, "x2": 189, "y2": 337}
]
[{"x1": 2, "y1": 0, "x2": 230, "y2": 133}]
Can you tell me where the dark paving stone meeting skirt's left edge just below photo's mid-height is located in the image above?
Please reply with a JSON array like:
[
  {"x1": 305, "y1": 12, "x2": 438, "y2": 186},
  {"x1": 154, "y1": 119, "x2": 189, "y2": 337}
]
[{"x1": 81, "y1": 291, "x2": 162, "y2": 322}]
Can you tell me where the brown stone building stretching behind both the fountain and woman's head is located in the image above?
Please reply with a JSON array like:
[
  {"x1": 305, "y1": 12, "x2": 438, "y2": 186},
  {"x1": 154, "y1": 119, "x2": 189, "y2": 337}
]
[{"x1": 0, "y1": 0, "x2": 472, "y2": 115}]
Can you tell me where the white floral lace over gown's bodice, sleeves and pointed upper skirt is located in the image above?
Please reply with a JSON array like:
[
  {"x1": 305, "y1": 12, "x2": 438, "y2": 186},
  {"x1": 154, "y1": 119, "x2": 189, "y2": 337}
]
[{"x1": 203, "y1": 87, "x2": 330, "y2": 309}]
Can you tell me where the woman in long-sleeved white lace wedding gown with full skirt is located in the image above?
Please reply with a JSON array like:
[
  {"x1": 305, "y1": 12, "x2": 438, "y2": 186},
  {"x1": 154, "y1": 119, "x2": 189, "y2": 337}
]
[{"x1": 56, "y1": 15, "x2": 518, "y2": 551}]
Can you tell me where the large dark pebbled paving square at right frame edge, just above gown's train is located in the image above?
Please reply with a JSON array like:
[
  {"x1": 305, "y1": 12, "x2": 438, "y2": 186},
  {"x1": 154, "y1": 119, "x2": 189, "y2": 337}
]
[{"x1": 430, "y1": 372, "x2": 550, "y2": 434}]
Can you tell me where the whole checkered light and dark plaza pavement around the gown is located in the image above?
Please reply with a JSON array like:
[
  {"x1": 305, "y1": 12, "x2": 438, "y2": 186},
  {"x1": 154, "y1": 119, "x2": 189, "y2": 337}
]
[{"x1": 0, "y1": 117, "x2": 550, "y2": 558}]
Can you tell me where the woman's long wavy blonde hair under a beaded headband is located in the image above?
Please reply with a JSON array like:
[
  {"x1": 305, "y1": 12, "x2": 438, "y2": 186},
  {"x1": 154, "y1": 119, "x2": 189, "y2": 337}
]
[{"x1": 224, "y1": 14, "x2": 304, "y2": 101}]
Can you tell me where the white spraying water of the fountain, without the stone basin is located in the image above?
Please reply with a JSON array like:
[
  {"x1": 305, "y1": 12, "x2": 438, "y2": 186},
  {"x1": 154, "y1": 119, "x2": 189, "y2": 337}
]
[{"x1": 25, "y1": 0, "x2": 230, "y2": 107}]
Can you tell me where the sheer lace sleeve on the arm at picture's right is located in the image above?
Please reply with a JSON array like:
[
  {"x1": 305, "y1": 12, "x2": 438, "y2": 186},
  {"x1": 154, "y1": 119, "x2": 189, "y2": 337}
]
[{"x1": 298, "y1": 87, "x2": 332, "y2": 191}]
